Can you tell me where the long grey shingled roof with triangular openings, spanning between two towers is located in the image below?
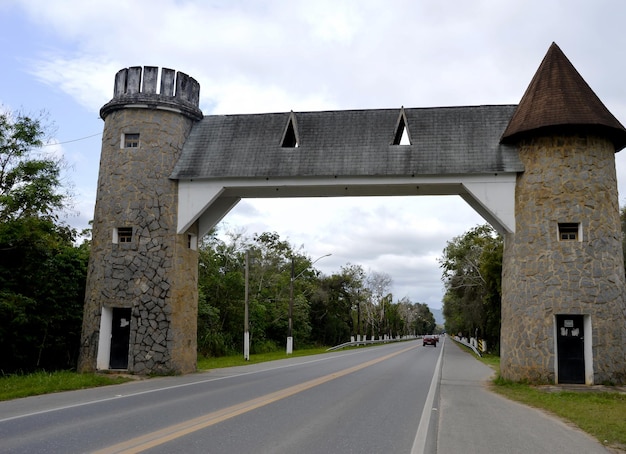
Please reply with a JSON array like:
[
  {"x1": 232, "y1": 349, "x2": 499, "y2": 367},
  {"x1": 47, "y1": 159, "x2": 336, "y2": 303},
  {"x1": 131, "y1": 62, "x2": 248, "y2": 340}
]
[{"x1": 171, "y1": 105, "x2": 524, "y2": 179}]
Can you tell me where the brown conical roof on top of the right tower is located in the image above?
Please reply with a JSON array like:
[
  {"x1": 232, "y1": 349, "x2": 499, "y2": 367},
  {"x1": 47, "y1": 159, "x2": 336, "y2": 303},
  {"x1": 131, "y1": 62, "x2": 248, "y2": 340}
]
[{"x1": 502, "y1": 43, "x2": 626, "y2": 151}]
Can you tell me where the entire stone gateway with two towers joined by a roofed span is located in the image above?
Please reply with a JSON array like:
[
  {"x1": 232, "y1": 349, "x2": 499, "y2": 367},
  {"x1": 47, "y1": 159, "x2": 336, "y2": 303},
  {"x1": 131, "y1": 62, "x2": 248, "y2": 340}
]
[{"x1": 81, "y1": 44, "x2": 626, "y2": 383}]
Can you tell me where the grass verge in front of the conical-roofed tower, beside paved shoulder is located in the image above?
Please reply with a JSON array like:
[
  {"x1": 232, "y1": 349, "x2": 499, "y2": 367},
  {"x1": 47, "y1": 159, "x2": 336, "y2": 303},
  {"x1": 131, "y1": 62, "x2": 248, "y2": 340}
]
[{"x1": 468, "y1": 349, "x2": 626, "y2": 452}]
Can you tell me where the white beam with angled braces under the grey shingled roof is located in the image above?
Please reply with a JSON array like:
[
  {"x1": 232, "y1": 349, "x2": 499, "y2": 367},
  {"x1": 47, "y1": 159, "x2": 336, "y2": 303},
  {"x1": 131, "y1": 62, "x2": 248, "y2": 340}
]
[{"x1": 178, "y1": 174, "x2": 517, "y2": 237}]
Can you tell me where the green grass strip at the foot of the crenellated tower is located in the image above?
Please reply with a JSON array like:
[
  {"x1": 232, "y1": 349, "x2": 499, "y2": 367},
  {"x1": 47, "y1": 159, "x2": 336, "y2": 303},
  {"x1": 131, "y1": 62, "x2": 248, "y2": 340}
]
[{"x1": 0, "y1": 371, "x2": 130, "y2": 401}]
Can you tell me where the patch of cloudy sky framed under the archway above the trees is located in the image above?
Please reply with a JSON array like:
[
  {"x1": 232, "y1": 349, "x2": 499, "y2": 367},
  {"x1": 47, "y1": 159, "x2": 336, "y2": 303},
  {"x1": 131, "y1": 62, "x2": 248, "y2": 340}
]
[{"x1": 214, "y1": 197, "x2": 484, "y2": 307}]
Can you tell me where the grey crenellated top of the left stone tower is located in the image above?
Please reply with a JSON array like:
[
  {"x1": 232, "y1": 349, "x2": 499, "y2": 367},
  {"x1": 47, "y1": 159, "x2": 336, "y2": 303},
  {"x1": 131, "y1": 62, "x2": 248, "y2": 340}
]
[{"x1": 100, "y1": 66, "x2": 203, "y2": 120}]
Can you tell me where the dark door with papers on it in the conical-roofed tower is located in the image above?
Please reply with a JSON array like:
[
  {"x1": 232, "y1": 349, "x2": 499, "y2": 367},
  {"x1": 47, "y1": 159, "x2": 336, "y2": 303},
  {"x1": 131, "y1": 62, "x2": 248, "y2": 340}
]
[{"x1": 556, "y1": 315, "x2": 585, "y2": 384}]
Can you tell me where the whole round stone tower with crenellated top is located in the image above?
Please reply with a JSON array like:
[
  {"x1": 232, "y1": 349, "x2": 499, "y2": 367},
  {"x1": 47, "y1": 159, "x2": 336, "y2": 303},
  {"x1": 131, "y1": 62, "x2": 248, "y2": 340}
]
[{"x1": 79, "y1": 66, "x2": 203, "y2": 374}]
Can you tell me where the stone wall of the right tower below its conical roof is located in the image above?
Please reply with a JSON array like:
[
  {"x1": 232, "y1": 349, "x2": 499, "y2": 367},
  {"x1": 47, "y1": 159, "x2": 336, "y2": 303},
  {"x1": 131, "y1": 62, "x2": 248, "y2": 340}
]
[{"x1": 501, "y1": 135, "x2": 626, "y2": 384}]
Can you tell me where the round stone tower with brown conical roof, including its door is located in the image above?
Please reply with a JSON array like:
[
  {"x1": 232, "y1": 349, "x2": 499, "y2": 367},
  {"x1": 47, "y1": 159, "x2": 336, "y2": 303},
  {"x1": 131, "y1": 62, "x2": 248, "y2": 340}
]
[{"x1": 501, "y1": 44, "x2": 626, "y2": 384}]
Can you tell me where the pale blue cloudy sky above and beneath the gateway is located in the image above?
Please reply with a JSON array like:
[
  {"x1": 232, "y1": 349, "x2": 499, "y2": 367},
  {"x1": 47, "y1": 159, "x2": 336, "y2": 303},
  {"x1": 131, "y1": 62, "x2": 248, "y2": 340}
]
[{"x1": 0, "y1": 0, "x2": 626, "y2": 309}]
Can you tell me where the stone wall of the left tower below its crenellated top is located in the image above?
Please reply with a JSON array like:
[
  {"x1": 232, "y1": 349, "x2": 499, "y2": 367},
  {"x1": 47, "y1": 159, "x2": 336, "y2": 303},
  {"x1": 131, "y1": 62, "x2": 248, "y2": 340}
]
[{"x1": 79, "y1": 108, "x2": 198, "y2": 374}]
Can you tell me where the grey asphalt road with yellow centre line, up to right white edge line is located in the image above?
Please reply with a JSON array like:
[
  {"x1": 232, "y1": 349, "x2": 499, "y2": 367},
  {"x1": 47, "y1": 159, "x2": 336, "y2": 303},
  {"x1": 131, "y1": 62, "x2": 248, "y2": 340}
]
[{"x1": 0, "y1": 341, "x2": 443, "y2": 454}]
